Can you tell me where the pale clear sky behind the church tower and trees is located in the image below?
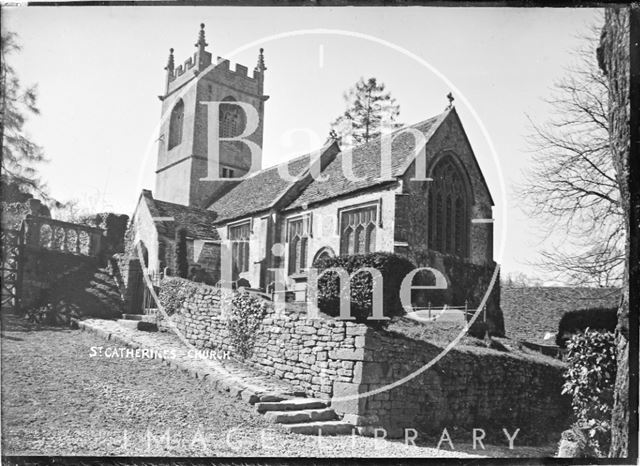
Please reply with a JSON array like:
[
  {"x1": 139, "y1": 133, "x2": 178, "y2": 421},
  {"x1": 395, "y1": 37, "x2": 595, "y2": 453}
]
[{"x1": 2, "y1": 6, "x2": 598, "y2": 280}]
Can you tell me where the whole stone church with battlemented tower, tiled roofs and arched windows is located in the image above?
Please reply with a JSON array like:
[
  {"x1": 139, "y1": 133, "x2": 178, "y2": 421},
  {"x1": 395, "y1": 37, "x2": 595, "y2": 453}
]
[{"x1": 131, "y1": 25, "x2": 502, "y2": 333}]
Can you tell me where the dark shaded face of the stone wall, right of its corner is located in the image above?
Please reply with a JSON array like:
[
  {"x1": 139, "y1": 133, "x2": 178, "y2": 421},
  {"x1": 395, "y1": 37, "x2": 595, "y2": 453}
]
[{"x1": 340, "y1": 330, "x2": 570, "y2": 438}]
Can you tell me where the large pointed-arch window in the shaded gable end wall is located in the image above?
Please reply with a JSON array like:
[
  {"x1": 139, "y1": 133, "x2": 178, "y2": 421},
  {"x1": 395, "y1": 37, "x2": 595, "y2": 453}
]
[{"x1": 428, "y1": 156, "x2": 470, "y2": 257}]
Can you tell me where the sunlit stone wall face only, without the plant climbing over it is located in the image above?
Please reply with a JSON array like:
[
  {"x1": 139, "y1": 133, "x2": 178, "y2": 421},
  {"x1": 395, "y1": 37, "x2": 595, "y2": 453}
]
[{"x1": 160, "y1": 277, "x2": 367, "y2": 398}]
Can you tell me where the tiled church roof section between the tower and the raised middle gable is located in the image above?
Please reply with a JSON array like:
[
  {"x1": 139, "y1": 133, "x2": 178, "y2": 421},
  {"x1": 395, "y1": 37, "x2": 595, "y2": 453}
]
[{"x1": 207, "y1": 146, "x2": 338, "y2": 222}]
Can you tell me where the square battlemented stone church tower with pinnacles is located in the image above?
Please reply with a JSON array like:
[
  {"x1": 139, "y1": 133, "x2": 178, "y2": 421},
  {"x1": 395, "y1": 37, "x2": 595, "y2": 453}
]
[{"x1": 154, "y1": 24, "x2": 268, "y2": 207}]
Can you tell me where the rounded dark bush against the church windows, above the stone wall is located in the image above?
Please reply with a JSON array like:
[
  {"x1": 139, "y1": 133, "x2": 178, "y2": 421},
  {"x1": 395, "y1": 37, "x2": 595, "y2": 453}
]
[{"x1": 314, "y1": 252, "x2": 415, "y2": 325}]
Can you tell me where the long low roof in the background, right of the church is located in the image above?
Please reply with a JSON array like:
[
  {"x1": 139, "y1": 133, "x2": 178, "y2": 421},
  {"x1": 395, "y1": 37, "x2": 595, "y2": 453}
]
[{"x1": 500, "y1": 286, "x2": 620, "y2": 345}]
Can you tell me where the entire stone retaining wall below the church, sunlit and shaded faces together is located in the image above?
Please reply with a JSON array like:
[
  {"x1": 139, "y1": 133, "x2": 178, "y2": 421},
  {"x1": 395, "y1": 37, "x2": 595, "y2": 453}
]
[{"x1": 161, "y1": 278, "x2": 568, "y2": 436}]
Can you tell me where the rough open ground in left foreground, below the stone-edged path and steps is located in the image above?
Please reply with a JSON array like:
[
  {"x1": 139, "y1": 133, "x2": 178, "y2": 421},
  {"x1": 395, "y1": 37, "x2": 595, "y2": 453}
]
[{"x1": 1, "y1": 319, "x2": 552, "y2": 457}]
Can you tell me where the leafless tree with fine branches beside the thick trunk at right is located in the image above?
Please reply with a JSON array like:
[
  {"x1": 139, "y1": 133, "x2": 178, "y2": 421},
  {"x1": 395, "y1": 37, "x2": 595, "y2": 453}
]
[{"x1": 518, "y1": 17, "x2": 625, "y2": 286}]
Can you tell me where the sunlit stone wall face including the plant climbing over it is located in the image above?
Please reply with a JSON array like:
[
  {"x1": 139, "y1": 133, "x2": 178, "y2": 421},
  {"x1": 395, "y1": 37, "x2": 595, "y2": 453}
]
[{"x1": 159, "y1": 277, "x2": 367, "y2": 398}]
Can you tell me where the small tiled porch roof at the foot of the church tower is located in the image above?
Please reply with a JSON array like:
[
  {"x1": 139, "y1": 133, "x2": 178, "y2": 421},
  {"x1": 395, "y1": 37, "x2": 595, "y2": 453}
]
[{"x1": 142, "y1": 190, "x2": 219, "y2": 239}]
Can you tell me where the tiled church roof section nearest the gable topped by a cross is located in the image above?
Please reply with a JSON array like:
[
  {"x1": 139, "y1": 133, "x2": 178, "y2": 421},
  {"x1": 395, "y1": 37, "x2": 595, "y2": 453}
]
[{"x1": 287, "y1": 111, "x2": 449, "y2": 210}]
